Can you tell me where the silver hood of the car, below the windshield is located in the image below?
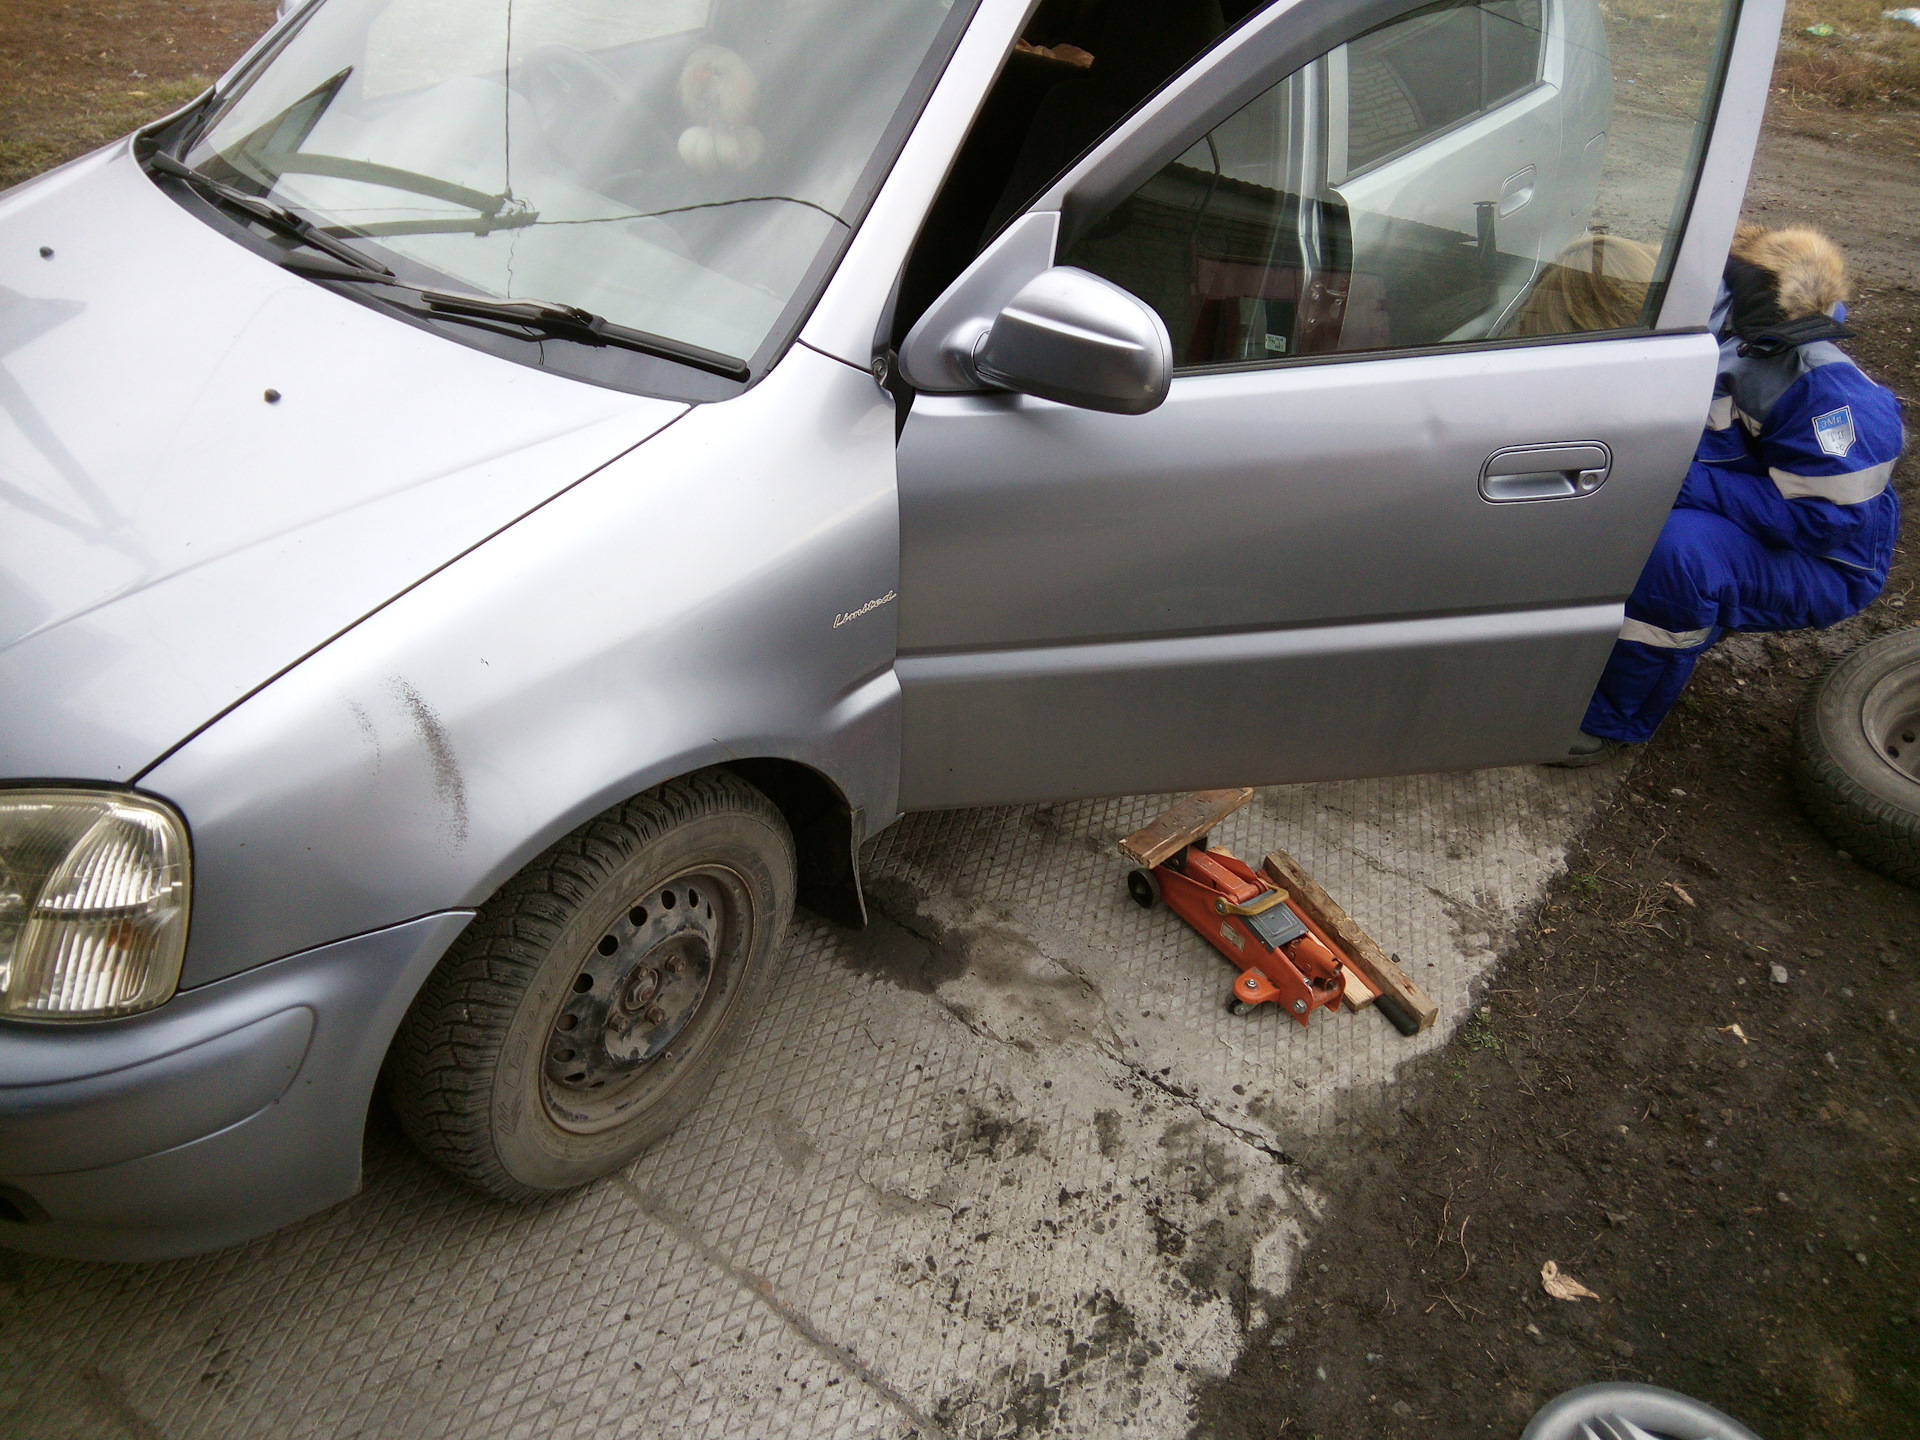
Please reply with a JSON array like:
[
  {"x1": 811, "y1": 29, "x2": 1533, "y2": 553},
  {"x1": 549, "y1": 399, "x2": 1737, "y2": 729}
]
[{"x1": 0, "y1": 142, "x2": 687, "y2": 780}]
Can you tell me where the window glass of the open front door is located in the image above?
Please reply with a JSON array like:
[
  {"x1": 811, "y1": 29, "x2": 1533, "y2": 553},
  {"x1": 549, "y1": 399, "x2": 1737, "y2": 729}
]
[{"x1": 1062, "y1": 0, "x2": 1732, "y2": 369}]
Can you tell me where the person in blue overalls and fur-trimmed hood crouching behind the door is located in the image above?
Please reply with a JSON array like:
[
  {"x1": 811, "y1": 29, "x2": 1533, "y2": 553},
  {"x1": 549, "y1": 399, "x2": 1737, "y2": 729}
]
[{"x1": 1559, "y1": 225, "x2": 1903, "y2": 764}]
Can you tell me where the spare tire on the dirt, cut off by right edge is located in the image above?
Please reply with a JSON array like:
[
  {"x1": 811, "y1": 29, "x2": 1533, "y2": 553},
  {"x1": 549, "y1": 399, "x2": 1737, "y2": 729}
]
[{"x1": 1795, "y1": 630, "x2": 1920, "y2": 885}]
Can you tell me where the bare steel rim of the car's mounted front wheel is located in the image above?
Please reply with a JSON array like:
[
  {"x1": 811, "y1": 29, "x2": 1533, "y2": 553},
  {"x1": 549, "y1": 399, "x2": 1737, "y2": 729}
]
[{"x1": 540, "y1": 866, "x2": 753, "y2": 1135}]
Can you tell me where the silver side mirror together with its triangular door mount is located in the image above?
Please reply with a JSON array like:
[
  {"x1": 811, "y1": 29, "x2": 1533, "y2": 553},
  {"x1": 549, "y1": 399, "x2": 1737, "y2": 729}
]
[{"x1": 900, "y1": 213, "x2": 1173, "y2": 415}]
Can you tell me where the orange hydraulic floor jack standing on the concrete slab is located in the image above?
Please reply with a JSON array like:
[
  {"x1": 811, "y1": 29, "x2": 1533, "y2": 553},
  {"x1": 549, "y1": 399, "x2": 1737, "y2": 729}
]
[{"x1": 1127, "y1": 835, "x2": 1352, "y2": 1025}]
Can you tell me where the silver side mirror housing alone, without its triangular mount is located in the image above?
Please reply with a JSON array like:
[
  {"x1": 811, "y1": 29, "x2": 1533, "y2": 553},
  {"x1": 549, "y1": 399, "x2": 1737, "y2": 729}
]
[{"x1": 962, "y1": 265, "x2": 1173, "y2": 415}]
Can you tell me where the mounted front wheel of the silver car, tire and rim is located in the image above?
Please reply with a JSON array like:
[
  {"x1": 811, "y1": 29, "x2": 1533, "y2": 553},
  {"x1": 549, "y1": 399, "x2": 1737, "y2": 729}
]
[{"x1": 388, "y1": 770, "x2": 795, "y2": 1202}]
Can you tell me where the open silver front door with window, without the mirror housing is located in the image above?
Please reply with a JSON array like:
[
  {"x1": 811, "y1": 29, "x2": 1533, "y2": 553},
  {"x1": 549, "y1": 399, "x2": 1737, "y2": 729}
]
[{"x1": 899, "y1": 0, "x2": 1780, "y2": 808}]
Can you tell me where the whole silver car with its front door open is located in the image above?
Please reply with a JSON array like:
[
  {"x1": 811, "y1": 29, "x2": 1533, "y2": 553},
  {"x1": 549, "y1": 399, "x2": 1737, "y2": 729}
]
[{"x1": 0, "y1": 0, "x2": 1780, "y2": 1260}]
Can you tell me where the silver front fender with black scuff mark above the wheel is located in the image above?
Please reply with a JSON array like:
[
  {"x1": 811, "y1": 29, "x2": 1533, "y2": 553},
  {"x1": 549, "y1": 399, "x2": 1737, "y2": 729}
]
[{"x1": 140, "y1": 348, "x2": 899, "y2": 987}]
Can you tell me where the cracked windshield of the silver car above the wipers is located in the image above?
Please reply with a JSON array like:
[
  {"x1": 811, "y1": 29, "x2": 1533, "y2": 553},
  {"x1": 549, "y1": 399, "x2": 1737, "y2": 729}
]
[{"x1": 186, "y1": 0, "x2": 952, "y2": 372}]
